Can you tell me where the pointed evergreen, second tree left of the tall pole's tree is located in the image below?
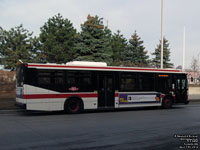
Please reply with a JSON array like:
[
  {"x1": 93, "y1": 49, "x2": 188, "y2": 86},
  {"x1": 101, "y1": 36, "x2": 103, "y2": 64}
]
[{"x1": 125, "y1": 31, "x2": 149, "y2": 67}]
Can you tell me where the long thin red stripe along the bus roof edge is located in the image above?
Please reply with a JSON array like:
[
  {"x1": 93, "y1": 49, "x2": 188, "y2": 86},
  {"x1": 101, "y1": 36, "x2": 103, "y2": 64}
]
[{"x1": 25, "y1": 64, "x2": 180, "y2": 72}]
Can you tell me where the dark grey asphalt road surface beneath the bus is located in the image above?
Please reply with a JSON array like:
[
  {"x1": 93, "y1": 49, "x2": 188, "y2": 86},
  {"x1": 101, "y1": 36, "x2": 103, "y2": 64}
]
[{"x1": 0, "y1": 103, "x2": 200, "y2": 150}]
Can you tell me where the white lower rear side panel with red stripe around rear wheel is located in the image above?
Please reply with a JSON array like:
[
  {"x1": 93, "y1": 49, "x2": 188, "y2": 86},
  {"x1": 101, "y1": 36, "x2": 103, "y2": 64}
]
[{"x1": 21, "y1": 84, "x2": 97, "y2": 111}]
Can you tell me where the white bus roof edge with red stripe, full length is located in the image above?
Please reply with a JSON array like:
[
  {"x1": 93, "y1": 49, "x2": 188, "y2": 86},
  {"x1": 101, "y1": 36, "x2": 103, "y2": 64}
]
[{"x1": 25, "y1": 63, "x2": 186, "y2": 74}]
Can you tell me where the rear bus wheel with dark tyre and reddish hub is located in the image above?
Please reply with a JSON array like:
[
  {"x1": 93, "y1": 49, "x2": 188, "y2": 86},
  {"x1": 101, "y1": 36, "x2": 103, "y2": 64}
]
[{"x1": 64, "y1": 98, "x2": 82, "y2": 114}]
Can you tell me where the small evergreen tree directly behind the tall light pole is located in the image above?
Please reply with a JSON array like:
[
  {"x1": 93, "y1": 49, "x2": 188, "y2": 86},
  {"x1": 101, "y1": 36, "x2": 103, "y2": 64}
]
[{"x1": 152, "y1": 38, "x2": 173, "y2": 68}]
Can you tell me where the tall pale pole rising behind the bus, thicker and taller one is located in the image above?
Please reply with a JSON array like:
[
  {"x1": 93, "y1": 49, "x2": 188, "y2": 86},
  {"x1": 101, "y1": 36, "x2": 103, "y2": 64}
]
[{"x1": 160, "y1": 0, "x2": 164, "y2": 69}]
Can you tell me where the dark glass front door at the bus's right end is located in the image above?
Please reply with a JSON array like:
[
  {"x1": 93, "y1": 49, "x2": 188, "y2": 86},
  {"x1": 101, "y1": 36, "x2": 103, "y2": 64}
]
[{"x1": 175, "y1": 78, "x2": 188, "y2": 103}]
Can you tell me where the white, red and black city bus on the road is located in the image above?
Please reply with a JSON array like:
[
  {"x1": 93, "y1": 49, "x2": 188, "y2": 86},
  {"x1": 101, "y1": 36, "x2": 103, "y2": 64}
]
[{"x1": 16, "y1": 61, "x2": 189, "y2": 113}]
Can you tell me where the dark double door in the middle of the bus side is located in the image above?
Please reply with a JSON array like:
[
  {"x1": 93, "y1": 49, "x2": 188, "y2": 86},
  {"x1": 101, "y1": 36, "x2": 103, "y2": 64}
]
[{"x1": 98, "y1": 74, "x2": 115, "y2": 108}]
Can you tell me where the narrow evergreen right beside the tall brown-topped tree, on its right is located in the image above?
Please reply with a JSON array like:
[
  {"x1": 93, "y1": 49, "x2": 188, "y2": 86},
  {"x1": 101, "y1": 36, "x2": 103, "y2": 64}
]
[{"x1": 111, "y1": 30, "x2": 127, "y2": 65}]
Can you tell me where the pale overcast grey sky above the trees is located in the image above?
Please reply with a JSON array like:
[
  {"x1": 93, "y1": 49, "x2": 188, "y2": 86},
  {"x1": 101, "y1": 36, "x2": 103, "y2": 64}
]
[{"x1": 0, "y1": 0, "x2": 200, "y2": 68}]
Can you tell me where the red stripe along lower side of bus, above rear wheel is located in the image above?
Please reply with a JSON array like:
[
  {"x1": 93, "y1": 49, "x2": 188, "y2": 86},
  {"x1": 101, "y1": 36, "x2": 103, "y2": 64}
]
[{"x1": 23, "y1": 93, "x2": 119, "y2": 99}]
